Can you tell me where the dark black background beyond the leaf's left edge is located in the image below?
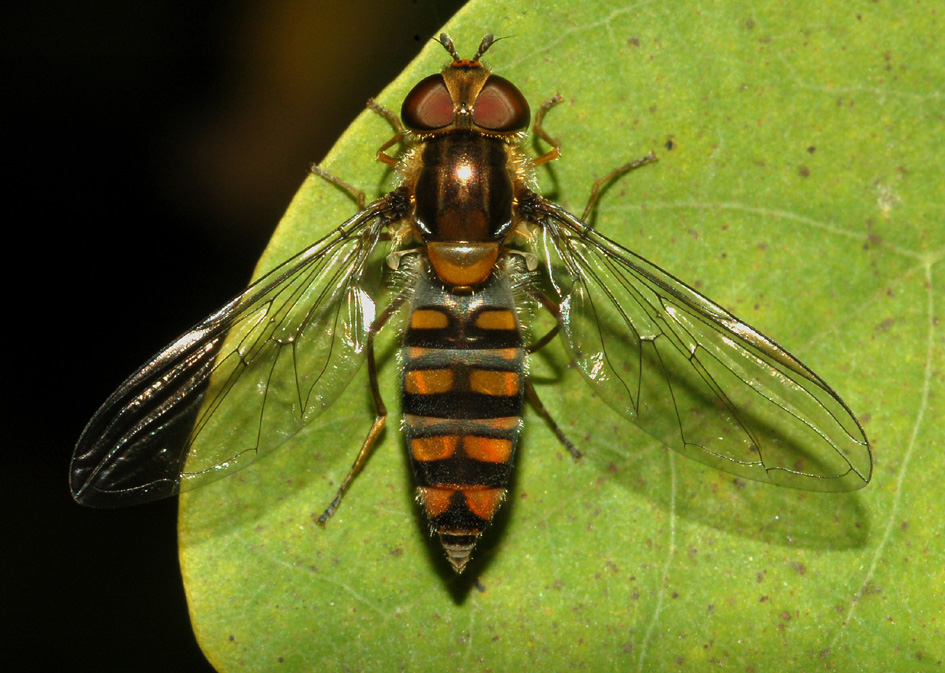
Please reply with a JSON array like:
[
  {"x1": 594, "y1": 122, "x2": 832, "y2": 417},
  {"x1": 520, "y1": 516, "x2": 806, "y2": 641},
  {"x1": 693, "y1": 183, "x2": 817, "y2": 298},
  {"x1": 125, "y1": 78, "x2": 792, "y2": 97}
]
[{"x1": 6, "y1": 0, "x2": 462, "y2": 672}]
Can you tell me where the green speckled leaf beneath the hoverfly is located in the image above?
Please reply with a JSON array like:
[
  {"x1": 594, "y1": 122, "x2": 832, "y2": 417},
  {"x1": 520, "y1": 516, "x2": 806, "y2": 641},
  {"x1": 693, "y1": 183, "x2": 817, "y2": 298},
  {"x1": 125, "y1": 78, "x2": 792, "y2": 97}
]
[{"x1": 180, "y1": 1, "x2": 945, "y2": 671}]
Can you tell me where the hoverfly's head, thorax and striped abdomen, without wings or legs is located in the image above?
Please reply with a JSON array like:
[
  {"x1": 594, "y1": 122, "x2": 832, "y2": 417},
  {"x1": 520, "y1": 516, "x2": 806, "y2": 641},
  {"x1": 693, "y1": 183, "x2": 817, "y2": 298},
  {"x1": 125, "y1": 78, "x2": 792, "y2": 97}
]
[{"x1": 392, "y1": 39, "x2": 530, "y2": 572}]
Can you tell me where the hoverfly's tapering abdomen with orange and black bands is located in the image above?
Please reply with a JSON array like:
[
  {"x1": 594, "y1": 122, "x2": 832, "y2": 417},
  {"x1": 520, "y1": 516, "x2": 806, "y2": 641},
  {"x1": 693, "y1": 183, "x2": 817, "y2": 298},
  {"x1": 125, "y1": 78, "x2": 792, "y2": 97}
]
[{"x1": 402, "y1": 270, "x2": 525, "y2": 571}]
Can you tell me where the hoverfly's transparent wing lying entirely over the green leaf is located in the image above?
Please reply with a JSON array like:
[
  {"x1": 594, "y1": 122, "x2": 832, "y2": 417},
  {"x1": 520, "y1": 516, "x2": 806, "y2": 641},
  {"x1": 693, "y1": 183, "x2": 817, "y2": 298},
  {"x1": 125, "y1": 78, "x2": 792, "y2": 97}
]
[{"x1": 525, "y1": 196, "x2": 872, "y2": 491}]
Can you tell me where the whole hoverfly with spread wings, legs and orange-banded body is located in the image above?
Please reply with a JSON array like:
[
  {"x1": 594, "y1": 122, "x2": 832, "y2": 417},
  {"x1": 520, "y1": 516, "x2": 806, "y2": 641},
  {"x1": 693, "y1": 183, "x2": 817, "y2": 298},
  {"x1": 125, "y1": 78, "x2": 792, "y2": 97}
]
[{"x1": 71, "y1": 34, "x2": 872, "y2": 572}]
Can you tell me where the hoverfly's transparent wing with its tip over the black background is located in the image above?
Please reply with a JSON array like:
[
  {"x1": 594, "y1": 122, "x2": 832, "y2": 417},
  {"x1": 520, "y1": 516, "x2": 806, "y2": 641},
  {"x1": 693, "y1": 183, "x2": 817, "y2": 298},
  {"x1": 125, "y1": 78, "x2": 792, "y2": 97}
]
[{"x1": 71, "y1": 195, "x2": 398, "y2": 507}]
